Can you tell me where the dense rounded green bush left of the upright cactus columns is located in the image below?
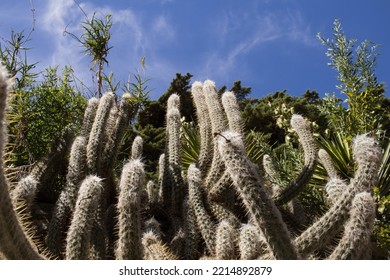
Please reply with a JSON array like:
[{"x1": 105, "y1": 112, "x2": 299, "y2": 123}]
[{"x1": 9, "y1": 68, "x2": 86, "y2": 165}]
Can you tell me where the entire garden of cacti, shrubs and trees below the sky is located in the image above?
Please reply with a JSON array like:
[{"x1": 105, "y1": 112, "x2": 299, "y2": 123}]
[{"x1": 0, "y1": 7, "x2": 390, "y2": 260}]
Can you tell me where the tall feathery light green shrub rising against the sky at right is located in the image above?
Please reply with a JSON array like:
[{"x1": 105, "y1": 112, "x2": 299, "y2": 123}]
[{"x1": 318, "y1": 20, "x2": 389, "y2": 137}]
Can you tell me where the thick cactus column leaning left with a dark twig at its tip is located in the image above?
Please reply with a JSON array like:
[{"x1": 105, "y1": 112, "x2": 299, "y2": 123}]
[{"x1": 218, "y1": 131, "x2": 299, "y2": 259}]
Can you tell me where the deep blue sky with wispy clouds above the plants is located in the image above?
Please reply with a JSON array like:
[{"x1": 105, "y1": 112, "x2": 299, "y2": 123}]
[{"x1": 0, "y1": 0, "x2": 390, "y2": 99}]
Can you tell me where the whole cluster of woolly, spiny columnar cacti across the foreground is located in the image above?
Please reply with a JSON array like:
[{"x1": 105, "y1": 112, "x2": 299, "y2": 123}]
[{"x1": 0, "y1": 64, "x2": 382, "y2": 260}]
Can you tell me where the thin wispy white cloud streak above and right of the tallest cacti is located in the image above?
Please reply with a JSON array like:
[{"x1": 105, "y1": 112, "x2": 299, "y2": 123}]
[{"x1": 199, "y1": 7, "x2": 318, "y2": 82}]
